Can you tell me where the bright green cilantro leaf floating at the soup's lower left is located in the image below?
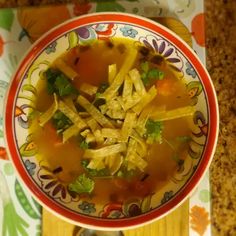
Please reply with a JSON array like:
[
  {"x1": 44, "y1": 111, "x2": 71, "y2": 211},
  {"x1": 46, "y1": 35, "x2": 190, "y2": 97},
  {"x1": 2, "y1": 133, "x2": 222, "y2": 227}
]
[{"x1": 68, "y1": 174, "x2": 94, "y2": 194}]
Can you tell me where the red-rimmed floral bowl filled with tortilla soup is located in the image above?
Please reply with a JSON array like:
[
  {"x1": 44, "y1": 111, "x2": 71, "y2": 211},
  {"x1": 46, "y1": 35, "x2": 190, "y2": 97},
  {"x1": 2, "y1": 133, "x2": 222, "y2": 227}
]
[{"x1": 5, "y1": 13, "x2": 219, "y2": 230}]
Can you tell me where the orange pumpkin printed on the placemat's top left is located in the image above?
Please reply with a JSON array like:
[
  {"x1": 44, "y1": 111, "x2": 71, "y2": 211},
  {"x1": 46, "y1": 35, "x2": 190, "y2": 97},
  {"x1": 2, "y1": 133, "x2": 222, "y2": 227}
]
[{"x1": 17, "y1": 5, "x2": 71, "y2": 42}]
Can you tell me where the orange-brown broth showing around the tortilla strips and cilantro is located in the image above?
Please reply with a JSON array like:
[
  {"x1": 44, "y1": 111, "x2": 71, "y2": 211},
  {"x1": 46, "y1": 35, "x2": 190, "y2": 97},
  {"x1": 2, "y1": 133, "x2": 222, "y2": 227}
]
[{"x1": 30, "y1": 39, "x2": 191, "y2": 203}]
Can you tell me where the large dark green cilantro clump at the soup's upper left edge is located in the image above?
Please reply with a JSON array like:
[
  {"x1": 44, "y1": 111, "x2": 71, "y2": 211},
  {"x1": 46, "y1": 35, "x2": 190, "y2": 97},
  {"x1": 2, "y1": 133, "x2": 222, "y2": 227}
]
[{"x1": 45, "y1": 68, "x2": 78, "y2": 96}]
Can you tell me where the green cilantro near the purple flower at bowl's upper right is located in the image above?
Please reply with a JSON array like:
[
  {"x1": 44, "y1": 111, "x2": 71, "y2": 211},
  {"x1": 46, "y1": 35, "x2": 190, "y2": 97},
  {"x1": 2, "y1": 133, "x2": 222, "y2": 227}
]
[{"x1": 141, "y1": 61, "x2": 164, "y2": 86}]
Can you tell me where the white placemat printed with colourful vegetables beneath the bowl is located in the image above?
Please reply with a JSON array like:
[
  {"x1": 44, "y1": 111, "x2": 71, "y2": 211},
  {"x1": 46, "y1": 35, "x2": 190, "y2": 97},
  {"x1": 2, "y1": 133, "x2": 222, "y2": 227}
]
[{"x1": 0, "y1": 0, "x2": 211, "y2": 236}]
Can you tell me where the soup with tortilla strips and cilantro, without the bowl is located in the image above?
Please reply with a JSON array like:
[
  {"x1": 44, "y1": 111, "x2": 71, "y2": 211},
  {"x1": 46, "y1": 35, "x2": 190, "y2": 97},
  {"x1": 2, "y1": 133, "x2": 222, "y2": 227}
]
[{"x1": 30, "y1": 39, "x2": 194, "y2": 201}]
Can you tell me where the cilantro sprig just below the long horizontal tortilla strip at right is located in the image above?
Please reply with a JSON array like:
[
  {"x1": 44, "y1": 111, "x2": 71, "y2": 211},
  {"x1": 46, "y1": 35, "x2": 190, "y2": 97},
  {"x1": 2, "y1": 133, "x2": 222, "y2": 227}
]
[{"x1": 145, "y1": 119, "x2": 163, "y2": 144}]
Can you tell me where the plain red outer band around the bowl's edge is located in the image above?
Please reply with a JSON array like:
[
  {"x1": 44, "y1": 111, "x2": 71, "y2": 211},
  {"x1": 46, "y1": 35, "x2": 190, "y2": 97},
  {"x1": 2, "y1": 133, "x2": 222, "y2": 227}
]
[{"x1": 4, "y1": 12, "x2": 219, "y2": 230}]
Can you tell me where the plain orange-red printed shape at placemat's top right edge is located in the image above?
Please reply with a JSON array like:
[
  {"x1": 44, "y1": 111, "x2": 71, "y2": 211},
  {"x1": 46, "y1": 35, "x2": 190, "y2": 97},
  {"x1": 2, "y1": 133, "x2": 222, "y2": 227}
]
[{"x1": 191, "y1": 13, "x2": 205, "y2": 47}]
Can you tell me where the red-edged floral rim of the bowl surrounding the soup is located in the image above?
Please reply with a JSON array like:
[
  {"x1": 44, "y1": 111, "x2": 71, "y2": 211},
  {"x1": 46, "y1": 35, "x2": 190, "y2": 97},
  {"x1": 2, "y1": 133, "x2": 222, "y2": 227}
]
[{"x1": 5, "y1": 13, "x2": 218, "y2": 228}]
